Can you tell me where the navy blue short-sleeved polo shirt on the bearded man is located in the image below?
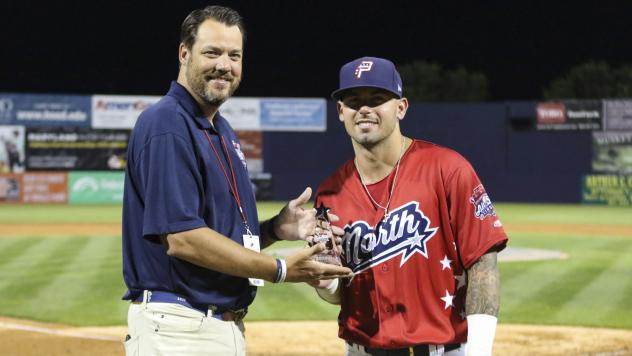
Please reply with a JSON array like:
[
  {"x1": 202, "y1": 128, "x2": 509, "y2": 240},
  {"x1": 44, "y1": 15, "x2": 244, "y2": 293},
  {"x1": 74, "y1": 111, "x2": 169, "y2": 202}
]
[{"x1": 123, "y1": 82, "x2": 259, "y2": 309}]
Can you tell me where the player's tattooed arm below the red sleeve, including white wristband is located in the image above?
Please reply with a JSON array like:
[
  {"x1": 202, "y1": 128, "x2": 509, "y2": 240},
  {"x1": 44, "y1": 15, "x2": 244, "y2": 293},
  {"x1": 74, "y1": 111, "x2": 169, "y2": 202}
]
[{"x1": 465, "y1": 250, "x2": 500, "y2": 356}]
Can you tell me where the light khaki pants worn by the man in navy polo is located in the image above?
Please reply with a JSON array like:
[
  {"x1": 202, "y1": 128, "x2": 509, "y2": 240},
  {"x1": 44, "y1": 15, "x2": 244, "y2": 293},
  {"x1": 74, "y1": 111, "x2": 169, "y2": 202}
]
[{"x1": 124, "y1": 298, "x2": 246, "y2": 356}]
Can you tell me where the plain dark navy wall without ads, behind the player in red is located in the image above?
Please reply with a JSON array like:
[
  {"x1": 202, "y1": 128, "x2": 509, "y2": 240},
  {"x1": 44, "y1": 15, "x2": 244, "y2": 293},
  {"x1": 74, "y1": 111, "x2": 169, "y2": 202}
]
[{"x1": 263, "y1": 101, "x2": 592, "y2": 203}]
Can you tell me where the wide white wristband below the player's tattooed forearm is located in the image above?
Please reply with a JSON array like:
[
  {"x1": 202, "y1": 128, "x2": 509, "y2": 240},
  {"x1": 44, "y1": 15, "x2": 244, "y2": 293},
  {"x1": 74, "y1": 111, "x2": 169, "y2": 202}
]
[{"x1": 465, "y1": 314, "x2": 498, "y2": 356}]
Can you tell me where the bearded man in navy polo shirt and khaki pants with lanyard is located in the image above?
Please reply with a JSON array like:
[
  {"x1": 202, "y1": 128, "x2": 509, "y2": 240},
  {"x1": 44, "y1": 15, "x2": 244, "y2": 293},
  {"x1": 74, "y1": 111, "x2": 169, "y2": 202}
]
[{"x1": 123, "y1": 6, "x2": 351, "y2": 355}]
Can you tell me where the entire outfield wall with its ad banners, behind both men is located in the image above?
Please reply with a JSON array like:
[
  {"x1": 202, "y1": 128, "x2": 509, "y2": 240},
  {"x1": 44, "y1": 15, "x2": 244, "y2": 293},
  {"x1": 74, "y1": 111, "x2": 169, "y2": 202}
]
[{"x1": 0, "y1": 93, "x2": 632, "y2": 205}]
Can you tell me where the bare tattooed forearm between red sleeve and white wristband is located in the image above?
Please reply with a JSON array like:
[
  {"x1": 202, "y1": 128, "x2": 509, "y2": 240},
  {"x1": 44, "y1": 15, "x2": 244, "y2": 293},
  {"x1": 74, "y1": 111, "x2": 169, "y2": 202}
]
[{"x1": 465, "y1": 252, "x2": 500, "y2": 316}]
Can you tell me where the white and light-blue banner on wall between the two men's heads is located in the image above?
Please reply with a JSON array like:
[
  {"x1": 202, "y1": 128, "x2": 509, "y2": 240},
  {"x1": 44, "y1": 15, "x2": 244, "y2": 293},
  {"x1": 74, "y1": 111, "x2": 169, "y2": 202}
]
[{"x1": 220, "y1": 98, "x2": 327, "y2": 132}]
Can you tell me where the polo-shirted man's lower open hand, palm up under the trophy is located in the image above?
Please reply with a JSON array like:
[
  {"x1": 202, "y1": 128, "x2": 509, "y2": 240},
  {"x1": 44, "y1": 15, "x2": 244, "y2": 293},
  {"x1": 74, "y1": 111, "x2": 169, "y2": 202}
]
[{"x1": 285, "y1": 243, "x2": 353, "y2": 282}]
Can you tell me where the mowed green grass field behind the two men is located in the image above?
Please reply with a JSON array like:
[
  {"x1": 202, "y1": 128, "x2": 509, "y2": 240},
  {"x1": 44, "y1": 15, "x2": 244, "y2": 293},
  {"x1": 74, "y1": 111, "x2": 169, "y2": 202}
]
[{"x1": 0, "y1": 203, "x2": 632, "y2": 329}]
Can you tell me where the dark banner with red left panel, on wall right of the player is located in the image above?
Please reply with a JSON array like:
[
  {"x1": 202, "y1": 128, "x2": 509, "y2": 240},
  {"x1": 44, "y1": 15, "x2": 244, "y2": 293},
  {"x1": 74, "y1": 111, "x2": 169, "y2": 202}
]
[{"x1": 535, "y1": 100, "x2": 603, "y2": 131}]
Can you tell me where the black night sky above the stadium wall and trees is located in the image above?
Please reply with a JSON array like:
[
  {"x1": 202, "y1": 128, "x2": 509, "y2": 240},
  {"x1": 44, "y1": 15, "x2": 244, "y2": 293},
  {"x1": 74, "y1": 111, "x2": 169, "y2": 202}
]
[{"x1": 0, "y1": 0, "x2": 632, "y2": 100}]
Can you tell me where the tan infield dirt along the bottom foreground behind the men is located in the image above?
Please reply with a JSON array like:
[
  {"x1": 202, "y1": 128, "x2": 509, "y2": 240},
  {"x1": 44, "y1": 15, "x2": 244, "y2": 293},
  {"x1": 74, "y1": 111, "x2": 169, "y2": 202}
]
[{"x1": 0, "y1": 318, "x2": 632, "y2": 356}]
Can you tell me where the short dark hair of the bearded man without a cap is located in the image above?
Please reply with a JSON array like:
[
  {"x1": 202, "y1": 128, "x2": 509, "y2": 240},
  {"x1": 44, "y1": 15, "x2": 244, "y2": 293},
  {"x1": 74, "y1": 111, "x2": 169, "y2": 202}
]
[{"x1": 180, "y1": 5, "x2": 246, "y2": 49}]
